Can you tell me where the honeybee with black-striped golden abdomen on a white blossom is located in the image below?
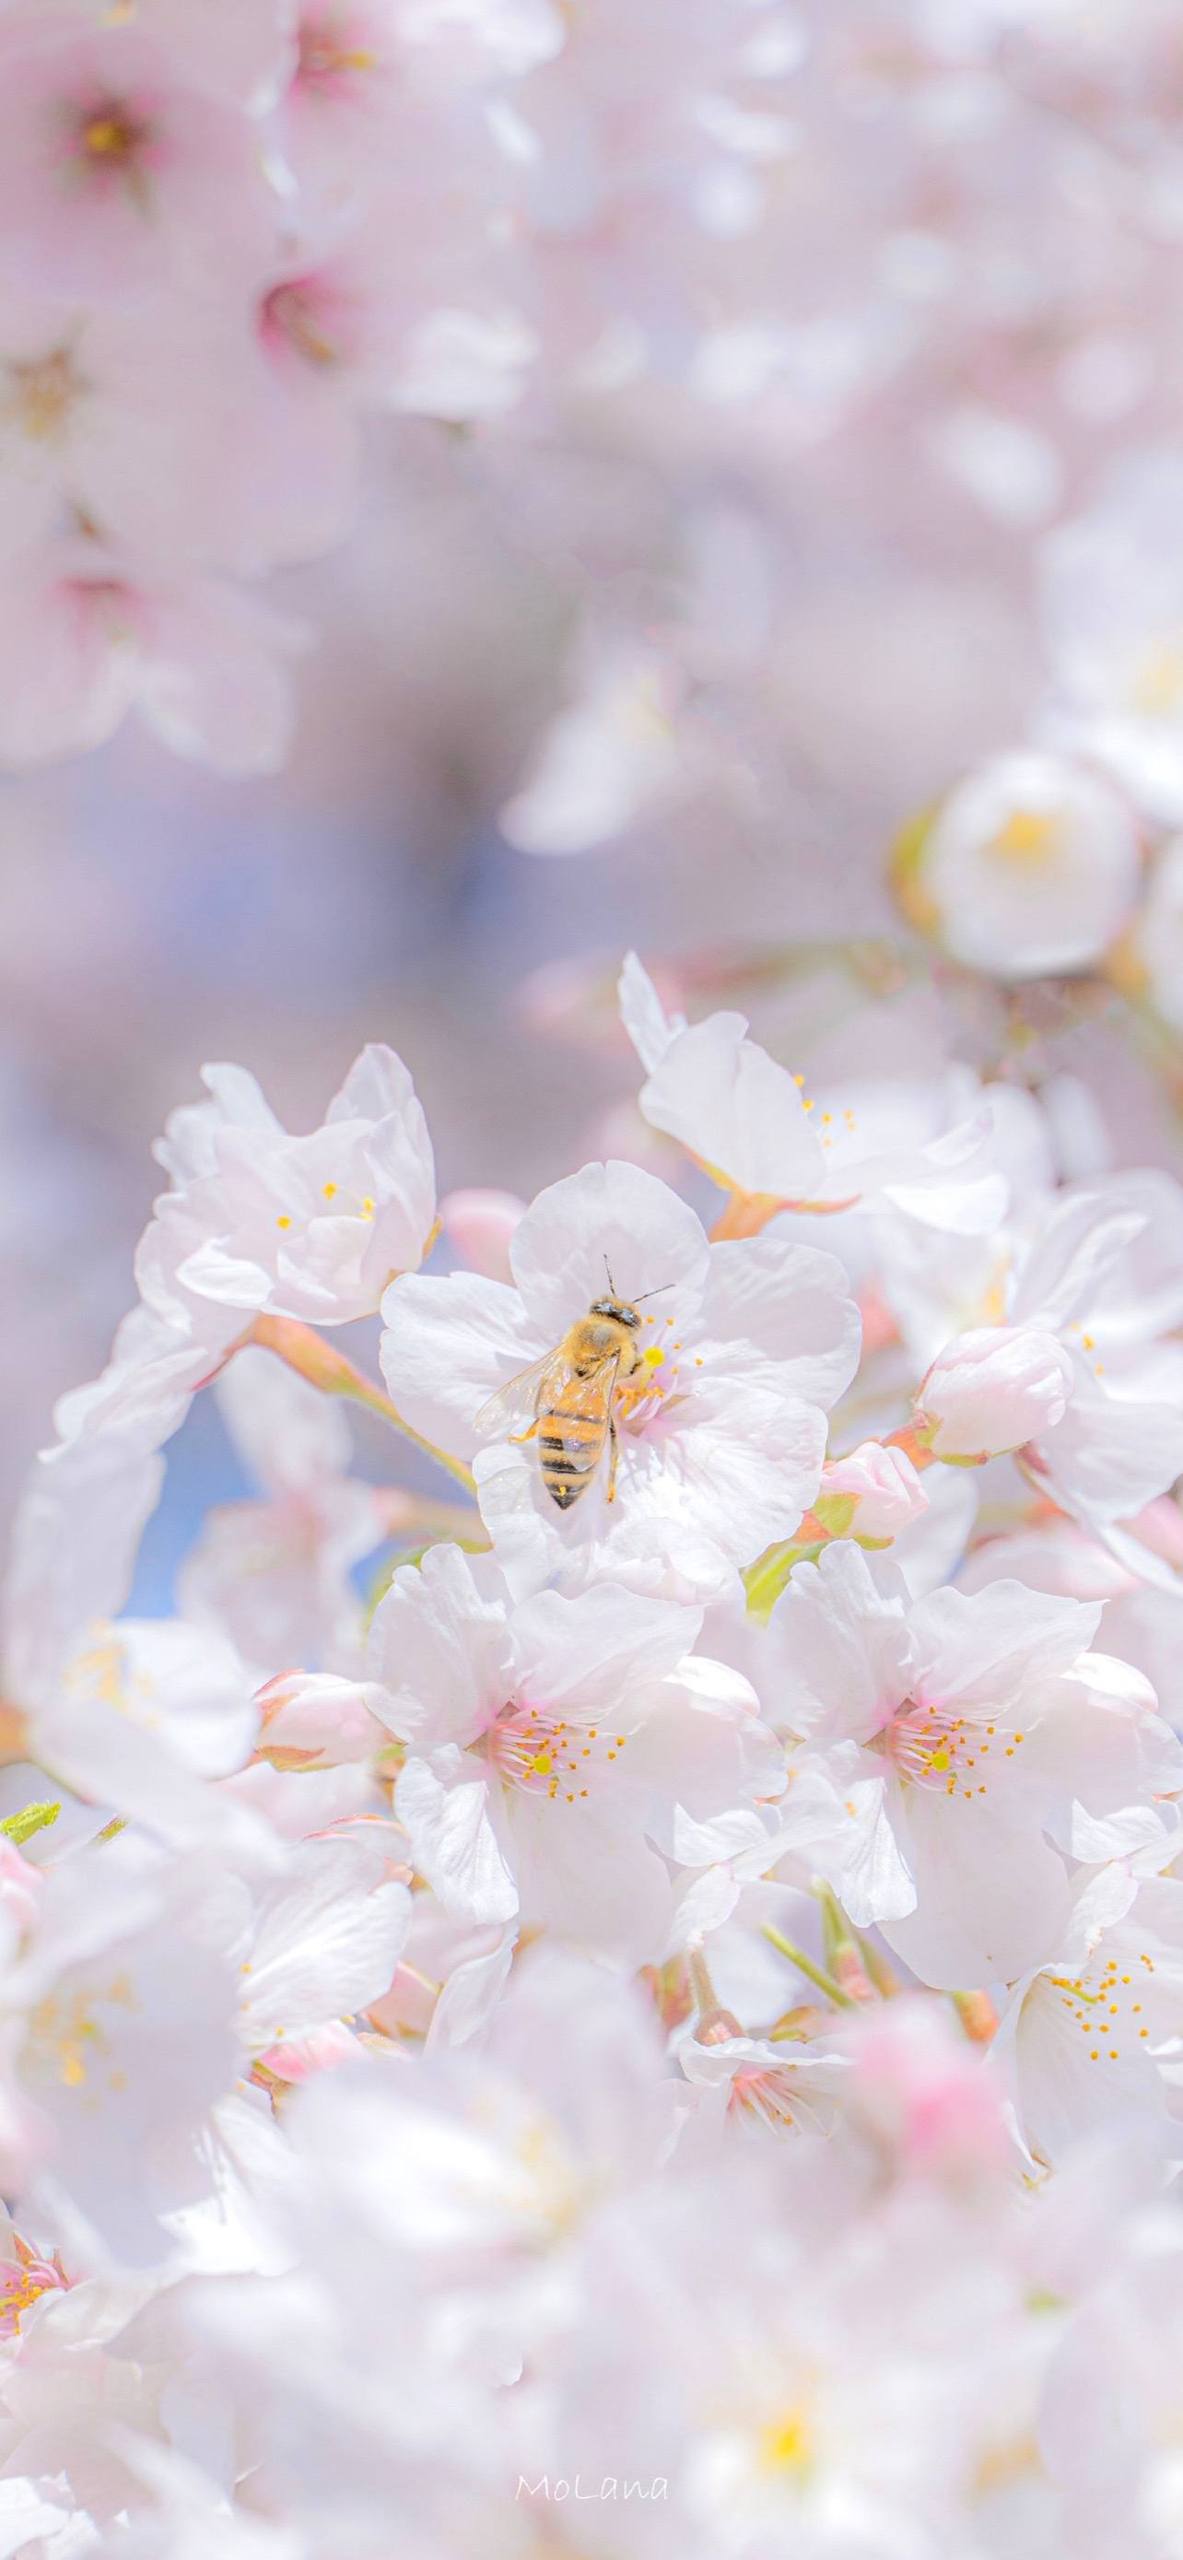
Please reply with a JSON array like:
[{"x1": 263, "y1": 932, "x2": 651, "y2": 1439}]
[{"x1": 476, "y1": 1262, "x2": 661, "y2": 1510}]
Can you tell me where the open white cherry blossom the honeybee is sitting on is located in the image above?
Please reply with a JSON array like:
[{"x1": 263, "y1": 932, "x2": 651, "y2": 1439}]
[{"x1": 382, "y1": 1162, "x2": 858, "y2": 1595}]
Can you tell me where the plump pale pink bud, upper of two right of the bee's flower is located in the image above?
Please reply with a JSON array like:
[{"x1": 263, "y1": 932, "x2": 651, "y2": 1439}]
[{"x1": 917, "y1": 1324, "x2": 1073, "y2": 1467}]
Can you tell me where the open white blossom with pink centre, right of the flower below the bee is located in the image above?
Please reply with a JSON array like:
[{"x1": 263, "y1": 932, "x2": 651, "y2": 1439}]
[{"x1": 766, "y1": 1544, "x2": 1183, "y2": 1989}]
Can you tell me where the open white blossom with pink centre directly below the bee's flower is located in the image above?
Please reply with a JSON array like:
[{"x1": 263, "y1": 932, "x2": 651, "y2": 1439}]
[{"x1": 366, "y1": 1546, "x2": 784, "y2": 1961}]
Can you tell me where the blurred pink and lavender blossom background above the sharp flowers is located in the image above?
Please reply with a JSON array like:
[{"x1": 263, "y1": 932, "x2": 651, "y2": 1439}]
[{"x1": 0, "y1": 0, "x2": 1183, "y2": 1556}]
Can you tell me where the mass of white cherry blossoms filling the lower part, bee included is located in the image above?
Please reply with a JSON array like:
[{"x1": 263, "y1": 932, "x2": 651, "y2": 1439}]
[{"x1": 0, "y1": 957, "x2": 1183, "y2": 2560}]
